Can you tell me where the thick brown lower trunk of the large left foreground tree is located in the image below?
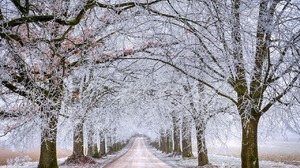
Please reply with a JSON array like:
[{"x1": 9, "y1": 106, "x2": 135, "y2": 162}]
[{"x1": 38, "y1": 114, "x2": 58, "y2": 168}]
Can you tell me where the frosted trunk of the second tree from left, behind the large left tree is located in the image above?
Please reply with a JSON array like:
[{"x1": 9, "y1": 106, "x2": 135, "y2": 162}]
[{"x1": 71, "y1": 122, "x2": 84, "y2": 157}]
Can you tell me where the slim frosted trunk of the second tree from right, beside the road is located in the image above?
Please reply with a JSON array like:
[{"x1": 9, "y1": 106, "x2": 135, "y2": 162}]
[{"x1": 195, "y1": 120, "x2": 208, "y2": 166}]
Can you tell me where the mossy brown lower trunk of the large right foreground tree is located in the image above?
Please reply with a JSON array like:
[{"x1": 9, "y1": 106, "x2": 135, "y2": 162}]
[{"x1": 241, "y1": 116, "x2": 260, "y2": 168}]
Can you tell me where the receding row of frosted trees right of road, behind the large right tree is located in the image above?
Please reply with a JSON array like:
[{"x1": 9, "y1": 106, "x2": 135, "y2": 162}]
[{"x1": 142, "y1": 72, "x2": 230, "y2": 166}]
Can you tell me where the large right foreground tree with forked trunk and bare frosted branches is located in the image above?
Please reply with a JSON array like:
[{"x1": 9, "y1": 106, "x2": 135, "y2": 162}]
[{"x1": 137, "y1": 0, "x2": 300, "y2": 167}]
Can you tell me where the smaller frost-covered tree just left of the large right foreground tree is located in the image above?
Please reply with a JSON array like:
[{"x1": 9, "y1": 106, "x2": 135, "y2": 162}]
[{"x1": 183, "y1": 81, "x2": 229, "y2": 166}]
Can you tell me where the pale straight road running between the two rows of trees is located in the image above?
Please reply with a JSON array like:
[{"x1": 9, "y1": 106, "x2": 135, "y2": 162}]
[{"x1": 106, "y1": 138, "x2": 171, "y2": 168}]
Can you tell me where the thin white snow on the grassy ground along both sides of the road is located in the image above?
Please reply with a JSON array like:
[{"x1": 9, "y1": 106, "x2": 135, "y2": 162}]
[{"x1": 0, "y1": 138, "x2": 299, "y2": 168}]
